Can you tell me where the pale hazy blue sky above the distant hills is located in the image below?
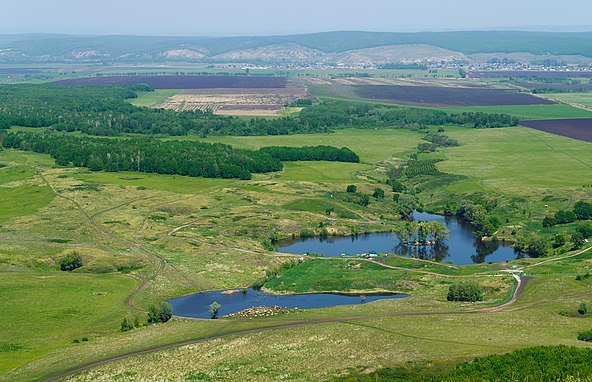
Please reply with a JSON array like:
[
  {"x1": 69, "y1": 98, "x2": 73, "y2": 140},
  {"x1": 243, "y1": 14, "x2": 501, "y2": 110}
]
[{"x1": 0, "y1": 0, "x2": 592, "y2": 36}]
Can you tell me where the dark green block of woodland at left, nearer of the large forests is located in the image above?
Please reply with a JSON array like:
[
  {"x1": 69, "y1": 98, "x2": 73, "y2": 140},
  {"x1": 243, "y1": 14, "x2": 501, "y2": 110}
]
[{"x1": 3, "y1": 132, "x2": 282, "y2": 179}]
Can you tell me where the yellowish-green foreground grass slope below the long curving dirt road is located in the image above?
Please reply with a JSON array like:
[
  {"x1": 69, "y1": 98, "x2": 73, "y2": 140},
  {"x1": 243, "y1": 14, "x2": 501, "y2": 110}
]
[{"x1": 63, "y1": 268, "x2": 591, "y2": 381}]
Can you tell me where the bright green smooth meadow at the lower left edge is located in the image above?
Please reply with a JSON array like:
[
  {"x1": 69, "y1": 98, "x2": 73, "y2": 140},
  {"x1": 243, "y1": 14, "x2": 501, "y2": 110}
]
[{"x1": 0, "y1": 272, "x2": 136, "y2": 374}]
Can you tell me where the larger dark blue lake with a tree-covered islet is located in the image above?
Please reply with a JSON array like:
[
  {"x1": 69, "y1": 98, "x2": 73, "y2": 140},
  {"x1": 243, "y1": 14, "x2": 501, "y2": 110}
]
[{"x1": 278, "y1": 211, "x2": 517, "y2": 265}]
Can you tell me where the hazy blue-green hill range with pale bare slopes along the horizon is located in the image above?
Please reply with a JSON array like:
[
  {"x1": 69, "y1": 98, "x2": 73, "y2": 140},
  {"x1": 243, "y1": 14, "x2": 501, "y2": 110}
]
[{"x1": 0, "y1": 31, "x2": 592, "y2": 65}]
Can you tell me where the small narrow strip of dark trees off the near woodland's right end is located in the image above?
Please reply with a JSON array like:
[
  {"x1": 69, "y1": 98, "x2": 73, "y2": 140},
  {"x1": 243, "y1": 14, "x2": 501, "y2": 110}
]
[{"x1": 259, "y1": 146, "x2": 360, "y2": 163}]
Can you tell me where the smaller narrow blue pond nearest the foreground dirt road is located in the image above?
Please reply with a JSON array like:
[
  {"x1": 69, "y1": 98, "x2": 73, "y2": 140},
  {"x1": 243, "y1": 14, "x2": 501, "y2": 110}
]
[{"x1": 167, "y1": 288, "x2": 408, "y2": 318}]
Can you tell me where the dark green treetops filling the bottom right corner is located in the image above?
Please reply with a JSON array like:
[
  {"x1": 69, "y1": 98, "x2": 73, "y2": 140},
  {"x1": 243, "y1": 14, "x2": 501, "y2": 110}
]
[{"x1": 338, "y1": 345, "x2": 592, "y2": 382}]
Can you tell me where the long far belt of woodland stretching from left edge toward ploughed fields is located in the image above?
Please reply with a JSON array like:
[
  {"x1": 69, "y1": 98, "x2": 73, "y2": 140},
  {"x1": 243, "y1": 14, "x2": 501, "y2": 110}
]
[{"x1": 0, "y1": 84, "x2": 518, "y2": 136}]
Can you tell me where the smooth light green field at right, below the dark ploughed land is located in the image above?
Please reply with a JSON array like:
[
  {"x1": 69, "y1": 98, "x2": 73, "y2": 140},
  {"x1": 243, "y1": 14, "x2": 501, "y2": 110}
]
[{"x1": 438, "y1": 127, "x2": 592, "y2": 197}]
